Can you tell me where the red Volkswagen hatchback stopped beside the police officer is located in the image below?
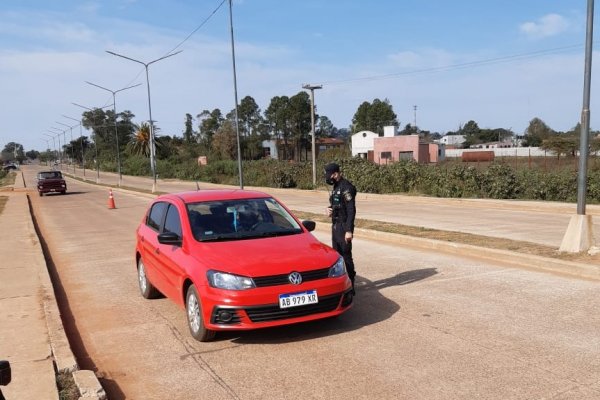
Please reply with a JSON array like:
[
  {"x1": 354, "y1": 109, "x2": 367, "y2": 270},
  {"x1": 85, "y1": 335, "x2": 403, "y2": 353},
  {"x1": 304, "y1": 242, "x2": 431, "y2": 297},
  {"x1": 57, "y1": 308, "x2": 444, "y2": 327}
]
[{"x1": 135, "y1": 190, "x2": 353, "y2": 341}]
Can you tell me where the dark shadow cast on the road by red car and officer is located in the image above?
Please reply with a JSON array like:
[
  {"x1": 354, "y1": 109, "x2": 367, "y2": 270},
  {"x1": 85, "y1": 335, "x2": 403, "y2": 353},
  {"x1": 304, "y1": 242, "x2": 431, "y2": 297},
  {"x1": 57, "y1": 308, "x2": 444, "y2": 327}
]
[{"x1": 225, "y1": 268, "x2": 437, "y2": 344}]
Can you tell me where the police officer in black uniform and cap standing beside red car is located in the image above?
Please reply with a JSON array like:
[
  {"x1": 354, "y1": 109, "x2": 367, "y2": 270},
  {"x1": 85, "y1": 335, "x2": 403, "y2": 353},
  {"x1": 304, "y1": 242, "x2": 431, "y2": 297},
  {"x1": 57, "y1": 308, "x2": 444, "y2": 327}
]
[{"x1": 325, "y1": 163, "x2": 356, "y2": 292}]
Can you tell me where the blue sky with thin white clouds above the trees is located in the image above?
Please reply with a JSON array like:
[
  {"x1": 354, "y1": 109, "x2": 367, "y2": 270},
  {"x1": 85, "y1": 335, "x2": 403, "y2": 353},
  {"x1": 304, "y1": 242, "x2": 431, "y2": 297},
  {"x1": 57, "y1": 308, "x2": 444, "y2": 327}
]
[{"x1": 0, "y1": 0, "x2": 600, "y2": 151}]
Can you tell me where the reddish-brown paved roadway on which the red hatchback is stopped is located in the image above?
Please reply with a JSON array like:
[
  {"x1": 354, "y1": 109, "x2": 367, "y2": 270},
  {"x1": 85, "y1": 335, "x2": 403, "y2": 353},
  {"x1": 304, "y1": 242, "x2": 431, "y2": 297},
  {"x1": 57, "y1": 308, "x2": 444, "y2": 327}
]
[{"x1": 23, "y1": 167, "x2": 600, "y2": 400}]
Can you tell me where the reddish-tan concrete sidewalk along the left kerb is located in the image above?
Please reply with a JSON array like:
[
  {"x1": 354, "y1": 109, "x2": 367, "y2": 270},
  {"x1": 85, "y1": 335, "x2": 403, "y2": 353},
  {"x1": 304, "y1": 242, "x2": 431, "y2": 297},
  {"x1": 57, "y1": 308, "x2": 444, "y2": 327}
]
[{"x1": 0, "y1": 172, "x2": 103, "y2": 400}]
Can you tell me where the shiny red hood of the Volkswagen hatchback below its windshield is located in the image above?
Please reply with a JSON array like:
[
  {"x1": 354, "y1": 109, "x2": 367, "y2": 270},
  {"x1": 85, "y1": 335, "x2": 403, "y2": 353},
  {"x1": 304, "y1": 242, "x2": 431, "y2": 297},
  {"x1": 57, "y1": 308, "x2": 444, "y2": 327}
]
[{"x1": 191, "y1": 233, "x2": 339, "y2": 276}]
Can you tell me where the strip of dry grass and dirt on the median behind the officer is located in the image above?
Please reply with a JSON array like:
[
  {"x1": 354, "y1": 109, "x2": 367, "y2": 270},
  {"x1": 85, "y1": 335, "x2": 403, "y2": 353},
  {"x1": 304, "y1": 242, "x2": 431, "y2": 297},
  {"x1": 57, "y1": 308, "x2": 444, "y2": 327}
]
[{"x1": 293, "y1": 211, "x2": 600, "y2": 264}]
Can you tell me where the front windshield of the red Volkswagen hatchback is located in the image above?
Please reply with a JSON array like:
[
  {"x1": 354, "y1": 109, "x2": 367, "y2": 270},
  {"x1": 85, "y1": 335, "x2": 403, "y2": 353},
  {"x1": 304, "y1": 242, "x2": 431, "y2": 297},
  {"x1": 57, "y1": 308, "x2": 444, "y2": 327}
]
[{"x1": 187, "y1": 198, "x2": 302, "y2": 242}]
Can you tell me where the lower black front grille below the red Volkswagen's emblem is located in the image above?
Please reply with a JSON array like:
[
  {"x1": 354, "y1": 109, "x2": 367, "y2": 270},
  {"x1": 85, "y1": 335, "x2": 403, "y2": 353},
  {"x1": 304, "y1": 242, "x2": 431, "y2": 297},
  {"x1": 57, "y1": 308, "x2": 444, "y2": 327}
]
[{"x1": 244, "y1": 294, "x2": 342, "y2": 322}]
